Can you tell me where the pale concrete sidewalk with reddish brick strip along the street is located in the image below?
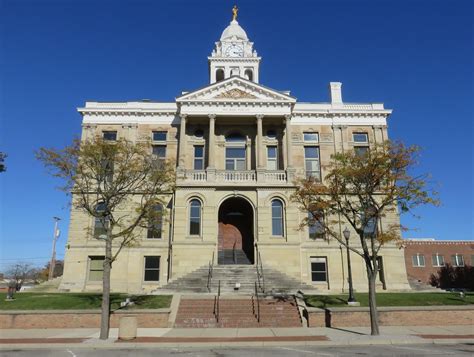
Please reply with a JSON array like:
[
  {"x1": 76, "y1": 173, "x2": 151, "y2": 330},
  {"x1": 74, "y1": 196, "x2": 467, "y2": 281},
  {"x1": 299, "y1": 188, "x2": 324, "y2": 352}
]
[{"x1": 0, "y1": 326, "x2": 474, "y2": 350}]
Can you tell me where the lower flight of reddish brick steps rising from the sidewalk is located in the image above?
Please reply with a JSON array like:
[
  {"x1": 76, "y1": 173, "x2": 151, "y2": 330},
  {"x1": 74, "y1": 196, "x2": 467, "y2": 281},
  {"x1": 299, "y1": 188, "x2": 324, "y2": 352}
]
[{"x1": 174, "y1": 296, "x2": 302, "y2": 328}]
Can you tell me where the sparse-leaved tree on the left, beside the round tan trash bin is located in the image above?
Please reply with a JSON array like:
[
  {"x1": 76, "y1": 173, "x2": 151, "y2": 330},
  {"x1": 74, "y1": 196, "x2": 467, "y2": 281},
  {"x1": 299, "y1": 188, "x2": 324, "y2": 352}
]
[{"x1": 37, "y1": 137, "x2": 175, "y2": 339}]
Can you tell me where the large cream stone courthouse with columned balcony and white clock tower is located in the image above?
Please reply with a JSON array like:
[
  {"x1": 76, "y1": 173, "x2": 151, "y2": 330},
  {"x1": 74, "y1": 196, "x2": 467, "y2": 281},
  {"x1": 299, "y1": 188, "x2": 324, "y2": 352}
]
[{"x1": 61, "y1": 13, "x2": 409, "y2": 293}]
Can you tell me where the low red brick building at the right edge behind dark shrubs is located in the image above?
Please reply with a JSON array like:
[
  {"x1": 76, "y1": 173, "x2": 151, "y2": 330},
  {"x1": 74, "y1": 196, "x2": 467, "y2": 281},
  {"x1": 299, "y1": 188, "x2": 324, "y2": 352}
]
[{"x1": 404, "y1": 239, "x2": 474, "y2": 284}]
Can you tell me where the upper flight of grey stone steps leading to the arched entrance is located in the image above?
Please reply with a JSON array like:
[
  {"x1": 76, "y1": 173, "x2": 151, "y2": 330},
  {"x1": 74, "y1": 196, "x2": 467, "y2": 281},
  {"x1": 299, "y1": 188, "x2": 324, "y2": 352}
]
[{"x1": 154, "y1": 265, "x2": 317, "y2": 295}]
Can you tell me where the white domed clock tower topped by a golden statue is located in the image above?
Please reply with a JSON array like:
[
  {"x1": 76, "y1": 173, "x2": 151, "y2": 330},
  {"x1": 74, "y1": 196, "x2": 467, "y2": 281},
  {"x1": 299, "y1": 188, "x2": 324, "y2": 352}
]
[{"x1": 208, "y1": 12, "x2": 261, "y2": 84}]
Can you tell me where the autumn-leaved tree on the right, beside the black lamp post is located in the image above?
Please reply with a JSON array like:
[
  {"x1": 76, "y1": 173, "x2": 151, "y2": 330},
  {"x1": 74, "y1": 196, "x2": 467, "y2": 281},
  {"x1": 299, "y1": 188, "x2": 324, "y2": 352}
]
[{"x1": 292, "y1": 141, "x2": 439, "y2": 335}]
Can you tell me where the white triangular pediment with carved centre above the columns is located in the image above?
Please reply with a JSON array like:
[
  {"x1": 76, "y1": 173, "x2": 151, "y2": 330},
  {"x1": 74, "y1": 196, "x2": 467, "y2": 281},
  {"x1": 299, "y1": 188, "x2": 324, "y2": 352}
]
[{"x1": 176, "y1": 77, "x2": 296, "y2": 103}]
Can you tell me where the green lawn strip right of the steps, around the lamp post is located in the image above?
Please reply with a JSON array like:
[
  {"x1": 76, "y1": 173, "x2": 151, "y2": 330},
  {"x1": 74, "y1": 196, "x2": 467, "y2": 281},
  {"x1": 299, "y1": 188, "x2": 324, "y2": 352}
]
[{"x1": 305, "y1": 292, "x2": 474, "y2": 308}]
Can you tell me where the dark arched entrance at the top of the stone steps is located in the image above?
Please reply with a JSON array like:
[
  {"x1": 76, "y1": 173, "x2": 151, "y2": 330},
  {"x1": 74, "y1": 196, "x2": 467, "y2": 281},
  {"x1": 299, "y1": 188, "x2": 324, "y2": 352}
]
[{"x1": 217, "y1": 197, "x2": 254, "y2": 264}]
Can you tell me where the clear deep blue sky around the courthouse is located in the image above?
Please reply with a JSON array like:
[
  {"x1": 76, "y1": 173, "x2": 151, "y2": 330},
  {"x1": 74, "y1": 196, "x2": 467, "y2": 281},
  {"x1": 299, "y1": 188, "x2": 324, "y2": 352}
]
[{"x1": 0, "y1": 0, "x2": 474, "y2": 271}]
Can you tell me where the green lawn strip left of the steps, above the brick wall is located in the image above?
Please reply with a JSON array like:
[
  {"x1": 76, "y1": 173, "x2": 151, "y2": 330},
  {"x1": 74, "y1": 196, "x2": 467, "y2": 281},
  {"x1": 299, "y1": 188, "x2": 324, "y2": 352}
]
[{"x1": 0, "y1": 292, "x2": 172, "y2": 310}]
